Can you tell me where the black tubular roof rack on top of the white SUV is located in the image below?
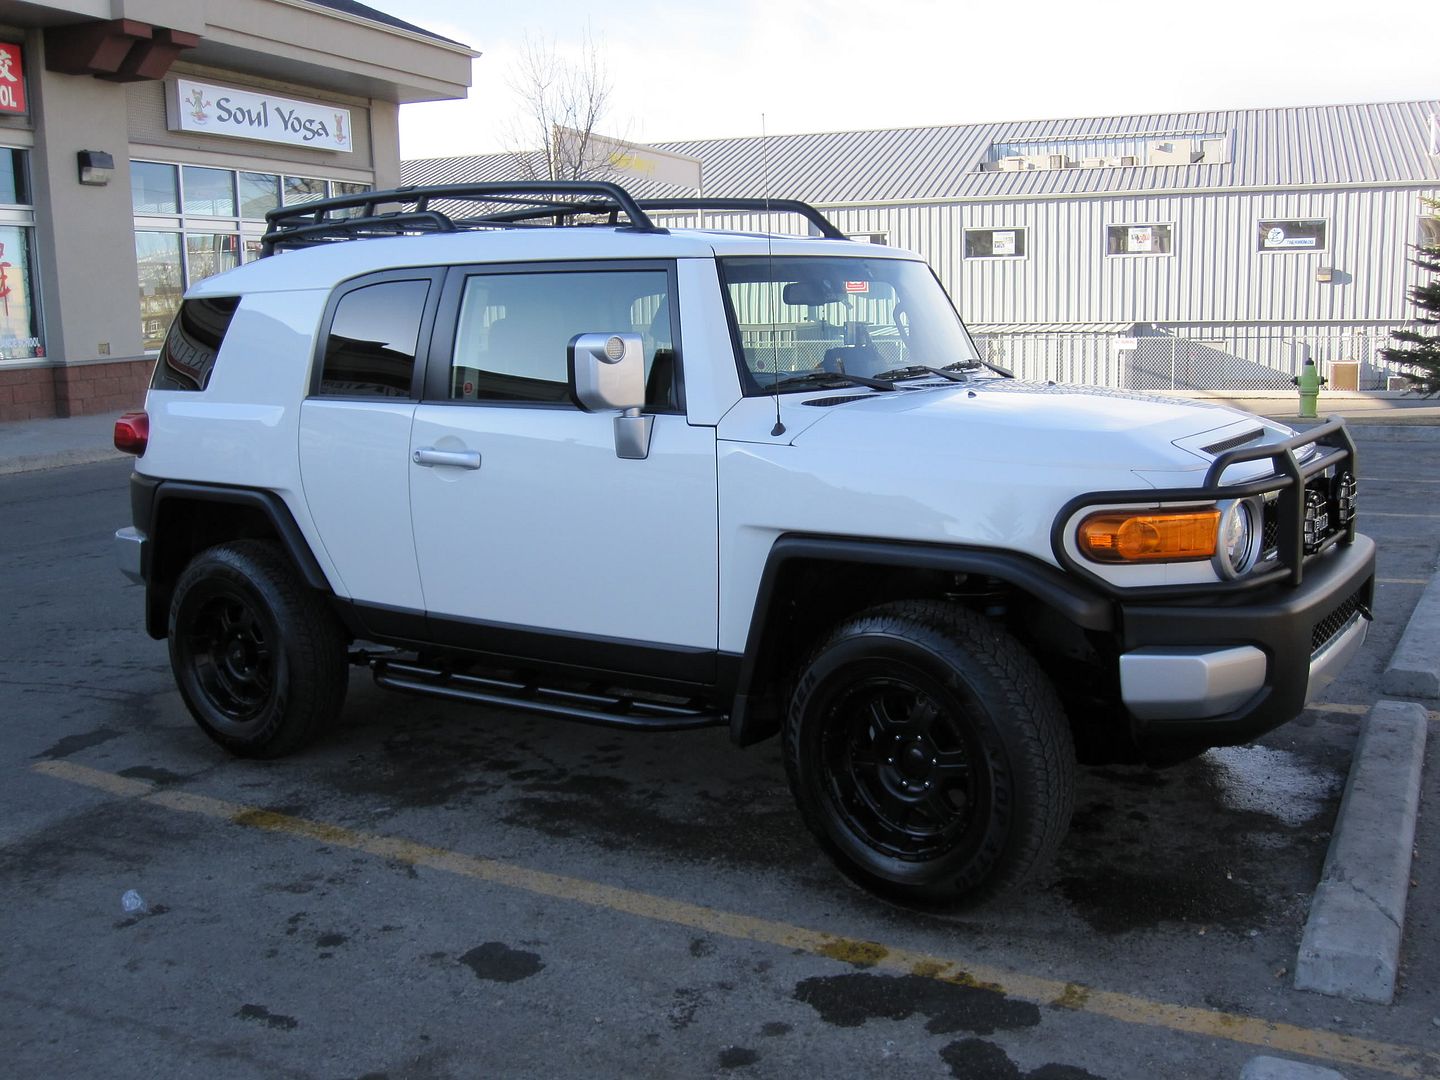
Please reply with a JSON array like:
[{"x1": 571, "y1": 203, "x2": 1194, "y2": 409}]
[{"x1": 261, "y1": 180, "x2": 847, "y2": 255}]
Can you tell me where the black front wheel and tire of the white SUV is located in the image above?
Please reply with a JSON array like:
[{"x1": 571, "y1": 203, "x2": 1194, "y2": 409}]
[{"x1": 785, "y1": 600, "x2": 1074, "y2": 906}]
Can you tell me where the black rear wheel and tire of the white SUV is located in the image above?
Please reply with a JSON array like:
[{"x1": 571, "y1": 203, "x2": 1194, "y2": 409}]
[{"x1": 168, "y1": 540, "x2": 348, "y2": 757}]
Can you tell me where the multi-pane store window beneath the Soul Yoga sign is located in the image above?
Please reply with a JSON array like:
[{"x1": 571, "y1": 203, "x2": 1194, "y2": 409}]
[{"x1": 133, "y1": 154, "x2": 370, "y2": 351}]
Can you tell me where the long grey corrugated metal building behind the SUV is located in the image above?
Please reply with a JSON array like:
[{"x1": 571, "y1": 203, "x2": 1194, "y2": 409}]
[{"x1": 403, "y1": 101, "x2": 1440, "y2": 390}]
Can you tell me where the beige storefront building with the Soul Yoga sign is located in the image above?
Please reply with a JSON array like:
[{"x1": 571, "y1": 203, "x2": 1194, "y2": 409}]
[{"x1": 0, "y1": 0, "x2": 475, "y2": 420}]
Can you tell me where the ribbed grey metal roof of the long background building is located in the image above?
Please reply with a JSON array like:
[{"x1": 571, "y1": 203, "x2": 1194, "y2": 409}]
[{"x1": 402, "y1": 101, "x2": 1440, "y2": 204}]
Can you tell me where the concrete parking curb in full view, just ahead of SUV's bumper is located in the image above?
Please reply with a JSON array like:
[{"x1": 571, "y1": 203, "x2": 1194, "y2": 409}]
[{"x1": 1295, "y1": 701, "x2": 1428, "y2": 1005}]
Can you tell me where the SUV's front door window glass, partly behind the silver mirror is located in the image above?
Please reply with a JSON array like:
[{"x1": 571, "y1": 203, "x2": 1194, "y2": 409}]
[{"x1": 449, "y1": 269, "x2": 678, "y2": 410}]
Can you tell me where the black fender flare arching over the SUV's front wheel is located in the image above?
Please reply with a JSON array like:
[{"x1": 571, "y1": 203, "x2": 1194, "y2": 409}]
[{"x1": 730, "y1": 533, "x2": 1119, "y2": 746}]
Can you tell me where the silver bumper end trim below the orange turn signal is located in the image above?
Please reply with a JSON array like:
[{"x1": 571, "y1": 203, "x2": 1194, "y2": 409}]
[{"x1": 1120, "y1": 645, "x2": 1266, "y2": 720}]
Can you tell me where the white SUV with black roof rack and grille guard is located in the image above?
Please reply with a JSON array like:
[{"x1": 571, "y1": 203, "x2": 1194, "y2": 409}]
[{"x1": 117, "y1": 181, "x2": 1374, "y2": 903}]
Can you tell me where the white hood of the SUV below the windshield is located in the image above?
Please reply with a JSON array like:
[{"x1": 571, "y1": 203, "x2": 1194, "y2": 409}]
[{"x1": 789, "y1": 379, "x2": 1287, "y2": 474}]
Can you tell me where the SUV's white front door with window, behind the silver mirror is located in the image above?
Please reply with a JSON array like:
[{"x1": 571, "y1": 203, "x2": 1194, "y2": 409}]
[{"x1": 409, "y1": 262, "x2": 717, "y2": 681}]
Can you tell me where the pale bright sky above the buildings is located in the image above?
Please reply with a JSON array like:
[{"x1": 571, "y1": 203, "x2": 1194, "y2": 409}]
[{"x1": 366, "y1": 0, "x2": 1440, "y2": 158}]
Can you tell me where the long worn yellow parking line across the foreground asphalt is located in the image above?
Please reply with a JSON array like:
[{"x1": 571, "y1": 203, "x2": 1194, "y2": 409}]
[{"x1": 32, "y1": 762, "x2": 1440, "y2": 1080}]
